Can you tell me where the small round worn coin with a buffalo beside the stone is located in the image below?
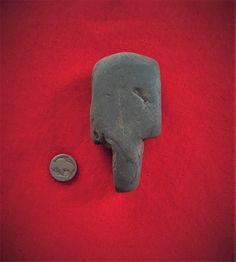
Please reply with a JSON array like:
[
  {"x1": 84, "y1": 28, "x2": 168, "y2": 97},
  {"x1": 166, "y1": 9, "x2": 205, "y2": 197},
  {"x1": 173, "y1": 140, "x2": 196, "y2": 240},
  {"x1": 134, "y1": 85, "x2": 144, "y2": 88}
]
[{"x1": 49, "y1": 154, "x2": 77, "y2": 182}]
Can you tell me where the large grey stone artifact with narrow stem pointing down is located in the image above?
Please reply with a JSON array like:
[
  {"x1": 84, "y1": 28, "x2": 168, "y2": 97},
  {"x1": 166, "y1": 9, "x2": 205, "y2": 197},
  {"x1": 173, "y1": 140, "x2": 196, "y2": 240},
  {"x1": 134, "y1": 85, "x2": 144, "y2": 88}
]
[{"x1": 90, "y1": 52, "x2": 161, "y2": 192}]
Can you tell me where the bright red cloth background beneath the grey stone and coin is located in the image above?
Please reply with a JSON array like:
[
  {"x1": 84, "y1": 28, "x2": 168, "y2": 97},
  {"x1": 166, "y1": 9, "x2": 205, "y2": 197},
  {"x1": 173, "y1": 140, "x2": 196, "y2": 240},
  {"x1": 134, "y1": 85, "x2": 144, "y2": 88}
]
[{"x1": 1, "y1": 0, "x2": 234, "y2": 261}]
